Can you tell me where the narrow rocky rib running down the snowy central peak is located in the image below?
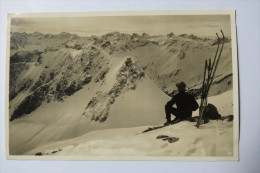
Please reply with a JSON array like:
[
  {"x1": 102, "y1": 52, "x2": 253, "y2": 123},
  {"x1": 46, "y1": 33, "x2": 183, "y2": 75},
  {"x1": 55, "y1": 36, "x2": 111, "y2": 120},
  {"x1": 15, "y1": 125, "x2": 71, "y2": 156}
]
[{"x1": 83, "y1": 58, "x2": 144, "y2": 122}]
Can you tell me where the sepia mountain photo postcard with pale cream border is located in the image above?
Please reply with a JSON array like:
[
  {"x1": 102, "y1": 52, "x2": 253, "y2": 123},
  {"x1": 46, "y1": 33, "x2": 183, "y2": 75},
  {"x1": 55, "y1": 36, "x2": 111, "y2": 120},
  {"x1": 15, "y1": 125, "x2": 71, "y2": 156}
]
[{"x1": 6, "y1": 10, "x2": 239, "y2": 161}]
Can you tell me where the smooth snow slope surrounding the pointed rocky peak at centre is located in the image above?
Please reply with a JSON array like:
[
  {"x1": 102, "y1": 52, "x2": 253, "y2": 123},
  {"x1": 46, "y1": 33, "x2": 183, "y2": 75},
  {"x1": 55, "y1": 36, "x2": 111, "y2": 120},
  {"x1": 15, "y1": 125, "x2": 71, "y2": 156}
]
[{"x1": 10, "y1": 58, "x2": 169, "y2": 154}]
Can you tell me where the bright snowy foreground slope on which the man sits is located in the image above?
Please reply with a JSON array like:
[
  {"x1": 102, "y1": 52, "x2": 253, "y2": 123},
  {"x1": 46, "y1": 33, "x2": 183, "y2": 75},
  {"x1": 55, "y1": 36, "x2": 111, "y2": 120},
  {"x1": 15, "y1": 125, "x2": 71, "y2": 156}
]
[{"x1": 25, "y1": 91, "x2": 236, "y2": 156}]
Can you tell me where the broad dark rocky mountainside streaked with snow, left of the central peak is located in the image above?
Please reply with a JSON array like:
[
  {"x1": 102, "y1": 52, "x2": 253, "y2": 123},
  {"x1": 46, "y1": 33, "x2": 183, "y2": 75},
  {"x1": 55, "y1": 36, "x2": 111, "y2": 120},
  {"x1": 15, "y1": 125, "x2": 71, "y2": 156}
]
[{"x1": 9, "y1": 46, "x2": 109, "y2": 121}]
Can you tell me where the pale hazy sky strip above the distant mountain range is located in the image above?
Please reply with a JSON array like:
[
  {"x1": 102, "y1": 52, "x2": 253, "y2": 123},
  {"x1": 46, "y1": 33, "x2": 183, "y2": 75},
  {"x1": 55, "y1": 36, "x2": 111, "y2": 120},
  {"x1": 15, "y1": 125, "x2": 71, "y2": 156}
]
[{"x1": 11, "y1": 15, "x2": 231, "y2": 36}]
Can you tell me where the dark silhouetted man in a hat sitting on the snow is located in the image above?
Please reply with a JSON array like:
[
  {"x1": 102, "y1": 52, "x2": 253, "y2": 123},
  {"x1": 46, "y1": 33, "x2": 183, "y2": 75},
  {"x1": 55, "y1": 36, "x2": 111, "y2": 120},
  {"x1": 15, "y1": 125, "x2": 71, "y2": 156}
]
[{"x1": 164, "y1": 82, "x2": 199, "y2": 125}]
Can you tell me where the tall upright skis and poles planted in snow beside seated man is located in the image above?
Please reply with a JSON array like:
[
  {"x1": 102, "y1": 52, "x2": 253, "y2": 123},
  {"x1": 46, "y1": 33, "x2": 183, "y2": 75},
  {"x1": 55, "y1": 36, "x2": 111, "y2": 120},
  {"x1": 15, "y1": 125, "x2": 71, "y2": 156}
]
[{"x1": 196, "y1": 30, "x2": 225, "y2": 128}]
